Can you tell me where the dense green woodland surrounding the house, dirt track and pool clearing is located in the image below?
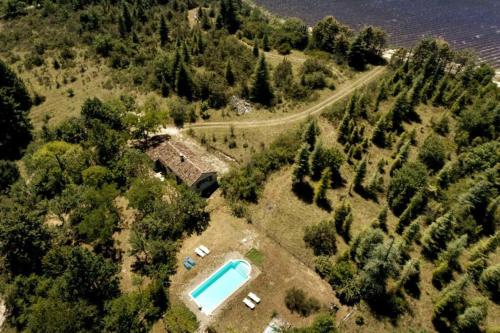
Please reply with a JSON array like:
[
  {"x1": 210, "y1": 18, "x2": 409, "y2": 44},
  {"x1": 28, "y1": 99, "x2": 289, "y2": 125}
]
[{"x1": 0, "y1": 0, "x2": 500, "y2": 333}]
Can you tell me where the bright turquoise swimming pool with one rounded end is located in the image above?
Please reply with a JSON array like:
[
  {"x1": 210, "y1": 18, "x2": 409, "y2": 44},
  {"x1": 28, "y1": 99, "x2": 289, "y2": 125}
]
[{"x1": 189, "y1": 260, "x2": 252, "y2": 315}]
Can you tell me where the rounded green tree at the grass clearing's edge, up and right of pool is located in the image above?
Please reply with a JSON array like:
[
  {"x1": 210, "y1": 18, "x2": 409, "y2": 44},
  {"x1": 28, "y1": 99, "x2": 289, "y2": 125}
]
[{"x1": 304, "y1": 221, "x2": 337, "y2": 256}]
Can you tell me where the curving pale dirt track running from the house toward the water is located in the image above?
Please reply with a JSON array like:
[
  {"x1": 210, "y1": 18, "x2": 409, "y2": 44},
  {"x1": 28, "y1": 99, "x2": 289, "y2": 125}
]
[{"x1": 184, "y1": 67, "x2": 385, "y2": 129}]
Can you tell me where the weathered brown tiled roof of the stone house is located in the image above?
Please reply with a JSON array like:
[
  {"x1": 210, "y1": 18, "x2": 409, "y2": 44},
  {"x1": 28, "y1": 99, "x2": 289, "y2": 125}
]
[{"x1": 147, "y1": 140, "x2": 215, "y2": 186}]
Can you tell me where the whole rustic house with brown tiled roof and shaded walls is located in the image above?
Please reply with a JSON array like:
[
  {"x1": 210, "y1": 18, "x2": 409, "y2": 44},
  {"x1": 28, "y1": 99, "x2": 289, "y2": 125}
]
[{"x1": 147, "y1": 140, "x2": 217, "y2": 193}]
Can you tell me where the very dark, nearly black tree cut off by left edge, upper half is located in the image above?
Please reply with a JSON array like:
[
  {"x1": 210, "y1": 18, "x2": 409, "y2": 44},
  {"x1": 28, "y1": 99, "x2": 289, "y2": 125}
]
[{"x1": 0, "y1": 60, "x2": 32, "y2": 160}]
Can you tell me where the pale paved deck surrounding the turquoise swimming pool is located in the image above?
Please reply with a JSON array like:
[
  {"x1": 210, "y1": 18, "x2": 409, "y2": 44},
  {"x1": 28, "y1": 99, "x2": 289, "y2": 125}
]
[{"x1": 181, "y1": 251, "x2": 261, "y2": 329}]
